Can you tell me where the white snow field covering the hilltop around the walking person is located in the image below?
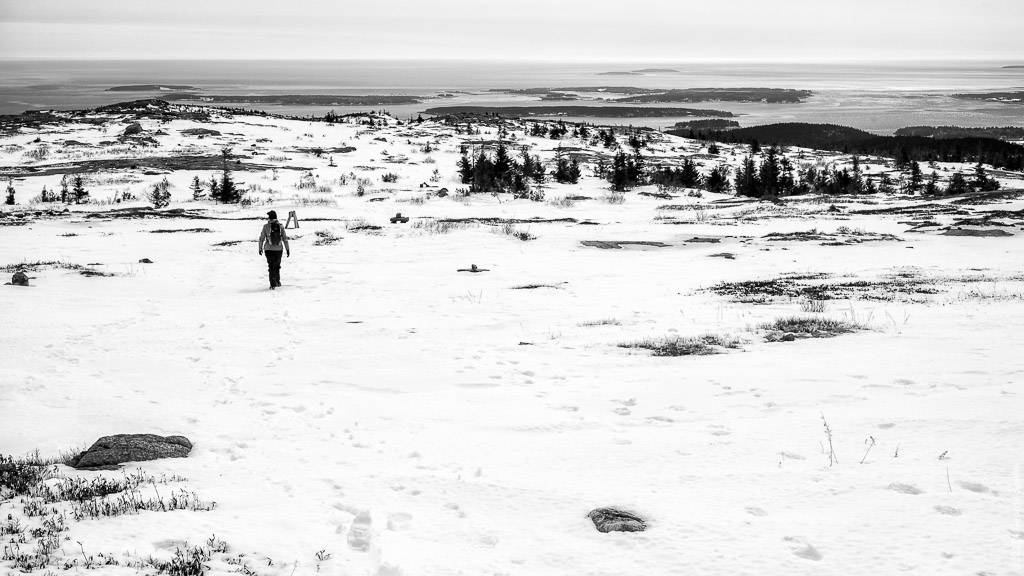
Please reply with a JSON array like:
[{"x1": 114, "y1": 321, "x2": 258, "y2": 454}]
[{"x1": 0, "y1": 104, "x2": 1024, "y2": 576}]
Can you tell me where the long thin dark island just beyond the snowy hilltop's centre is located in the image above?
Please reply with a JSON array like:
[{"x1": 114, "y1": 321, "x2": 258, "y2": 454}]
[{"x1": 424, "y1": 106, "x2": 733, "y2": 118}]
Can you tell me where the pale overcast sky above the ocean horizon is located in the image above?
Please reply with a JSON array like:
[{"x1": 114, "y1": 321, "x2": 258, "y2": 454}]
[{"x1": 0, "y1": 0, "x2": 1024, "y2": 61}]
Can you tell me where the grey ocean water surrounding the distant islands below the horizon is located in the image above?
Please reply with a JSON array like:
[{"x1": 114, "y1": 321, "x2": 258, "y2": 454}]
[{"x1": 0, "y1": 60, "x2": 1024, "y2": 133}]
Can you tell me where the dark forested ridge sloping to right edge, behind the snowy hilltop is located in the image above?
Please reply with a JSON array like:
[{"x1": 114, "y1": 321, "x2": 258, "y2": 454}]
[{"x1": 706, "y1": 122, "x2": 1024, "y2": 170}]
